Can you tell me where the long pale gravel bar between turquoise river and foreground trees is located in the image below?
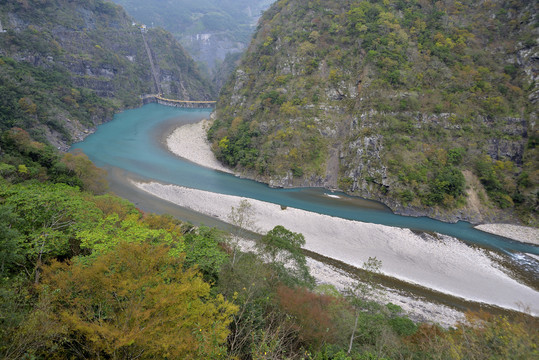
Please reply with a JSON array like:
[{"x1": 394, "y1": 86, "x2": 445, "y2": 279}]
[{"x1": 135, "y1": 182, "x2": 539, "y2": 316}]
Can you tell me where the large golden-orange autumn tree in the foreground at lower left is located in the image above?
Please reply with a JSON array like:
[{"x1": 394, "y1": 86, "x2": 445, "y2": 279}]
[{"x1": 31, "y1": 242, "x2": 237, "y2": 359}]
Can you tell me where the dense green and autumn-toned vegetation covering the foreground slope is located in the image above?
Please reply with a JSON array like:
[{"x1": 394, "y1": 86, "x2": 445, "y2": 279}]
[{"x1": 0, "y1": 129, "x2": 539, "y2": 360}]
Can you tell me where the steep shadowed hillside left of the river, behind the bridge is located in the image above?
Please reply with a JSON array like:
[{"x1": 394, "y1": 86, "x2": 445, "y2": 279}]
[{"x1": 0, "y1": 0, "x2": 213, "y2": 147}]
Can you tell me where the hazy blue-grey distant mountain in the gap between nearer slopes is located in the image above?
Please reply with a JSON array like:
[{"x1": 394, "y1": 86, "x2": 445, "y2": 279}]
[{"x1": 113, "y1": 0, "x2": 274, "y2": 84}]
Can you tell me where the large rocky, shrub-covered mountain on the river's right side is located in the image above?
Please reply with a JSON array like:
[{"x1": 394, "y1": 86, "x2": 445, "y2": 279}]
[{"x1": 208, "y1": 0, "x2": 539, "y2": 224}]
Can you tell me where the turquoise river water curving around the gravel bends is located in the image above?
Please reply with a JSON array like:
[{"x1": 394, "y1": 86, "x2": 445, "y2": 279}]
[{"x1": 72, "y1": 104, "x2": 539, "y2": 262}]
